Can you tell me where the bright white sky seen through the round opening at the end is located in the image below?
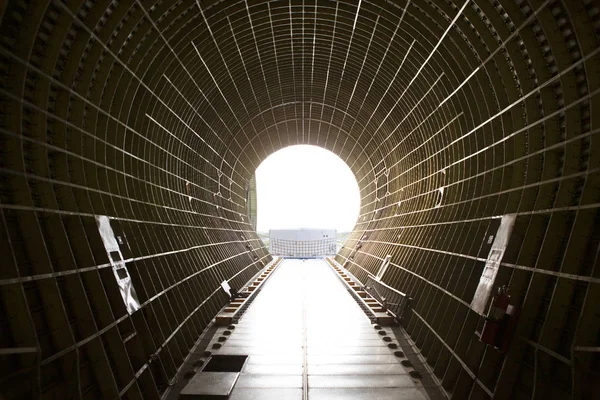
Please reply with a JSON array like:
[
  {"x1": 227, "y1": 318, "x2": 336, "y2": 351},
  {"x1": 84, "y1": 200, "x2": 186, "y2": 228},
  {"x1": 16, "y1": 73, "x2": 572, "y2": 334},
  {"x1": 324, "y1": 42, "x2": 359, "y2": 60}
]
[{"x1": 256, "y1": 145, "x2": 360, "y2": 232}]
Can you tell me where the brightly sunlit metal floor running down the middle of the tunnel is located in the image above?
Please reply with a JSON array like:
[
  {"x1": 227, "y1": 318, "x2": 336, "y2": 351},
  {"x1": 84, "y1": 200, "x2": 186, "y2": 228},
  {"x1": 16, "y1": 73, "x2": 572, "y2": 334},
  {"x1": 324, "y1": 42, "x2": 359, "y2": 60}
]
[{"x1": 213, "y1": 260, "x2": 428, "y2": 399}]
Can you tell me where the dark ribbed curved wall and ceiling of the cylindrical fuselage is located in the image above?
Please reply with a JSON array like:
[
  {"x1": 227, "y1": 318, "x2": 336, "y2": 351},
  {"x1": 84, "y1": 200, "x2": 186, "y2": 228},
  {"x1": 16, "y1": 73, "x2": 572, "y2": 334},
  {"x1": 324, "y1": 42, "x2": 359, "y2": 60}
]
[{"x1": 0, "y1": 0, "x2": 600, "y2": 399}]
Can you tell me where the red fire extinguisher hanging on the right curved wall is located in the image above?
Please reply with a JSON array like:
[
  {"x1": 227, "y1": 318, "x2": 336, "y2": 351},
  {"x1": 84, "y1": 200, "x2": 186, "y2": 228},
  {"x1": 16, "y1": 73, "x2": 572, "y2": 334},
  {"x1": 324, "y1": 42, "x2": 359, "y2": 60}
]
[{"x1": 479, "y1": 286, "x2": 518, "y2": 352}]
